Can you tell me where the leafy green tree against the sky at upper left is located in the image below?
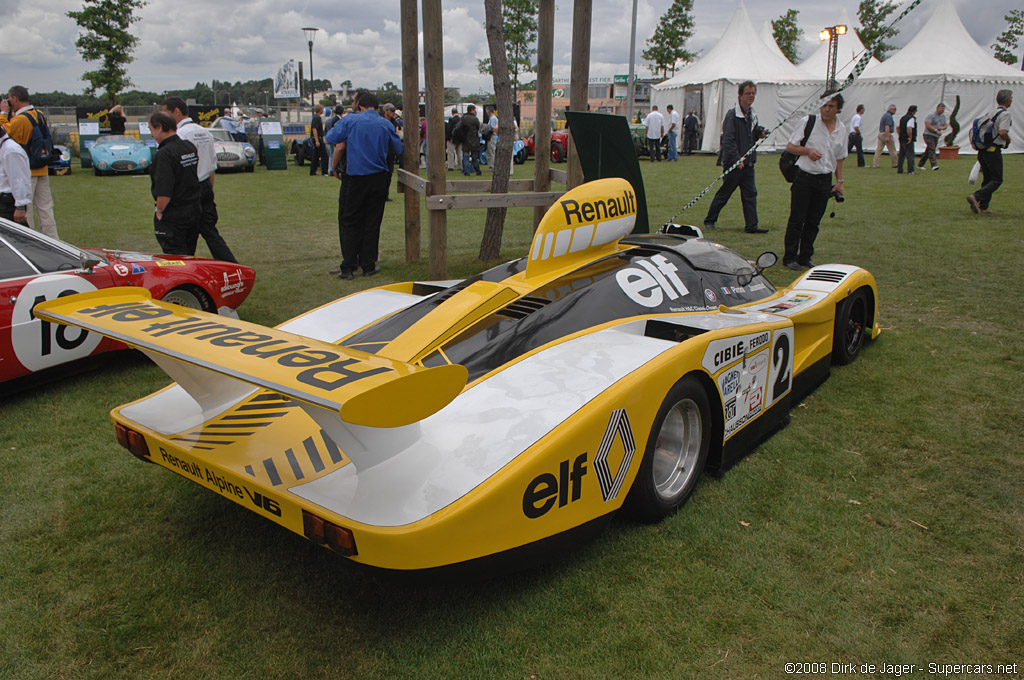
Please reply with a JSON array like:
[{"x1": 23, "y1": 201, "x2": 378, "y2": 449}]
[{"x1": 68, "y1": 0, "x2": 146, "y2": 104}]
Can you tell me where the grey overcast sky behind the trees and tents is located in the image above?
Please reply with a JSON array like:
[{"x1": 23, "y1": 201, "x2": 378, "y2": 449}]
[{"x1": 0, "y1": 0, "x2": 1022, "y2": 100}]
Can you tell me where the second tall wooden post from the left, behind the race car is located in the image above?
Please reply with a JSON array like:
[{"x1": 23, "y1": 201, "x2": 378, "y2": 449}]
[{"x1": 421, "y1": 0, "x2": 447, "y2": 281}]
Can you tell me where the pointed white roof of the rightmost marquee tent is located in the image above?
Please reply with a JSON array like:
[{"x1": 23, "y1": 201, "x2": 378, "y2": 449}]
[{"x1": 863, "y1": 0, "x2": 1022, "y2": 82}]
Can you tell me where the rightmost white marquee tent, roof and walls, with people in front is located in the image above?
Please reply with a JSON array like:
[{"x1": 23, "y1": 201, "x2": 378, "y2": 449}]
[{"x1": 841, "y1": 0, "x2": 1024, "y2": 153}]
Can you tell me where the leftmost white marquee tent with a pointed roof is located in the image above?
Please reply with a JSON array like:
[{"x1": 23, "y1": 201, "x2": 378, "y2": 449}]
[{"x1": 651, "y1": 0, "x2": 822, "y2": 152}]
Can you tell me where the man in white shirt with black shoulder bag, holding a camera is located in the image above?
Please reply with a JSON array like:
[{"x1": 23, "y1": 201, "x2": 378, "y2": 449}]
[{"x1": 782, "y1": 94, "x2": 849, "y2": 271}]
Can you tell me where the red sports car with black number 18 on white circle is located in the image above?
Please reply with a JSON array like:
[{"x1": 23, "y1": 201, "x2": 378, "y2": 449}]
[{"x1": 0, "y1": 219, "x2": 256, "y2": 392}]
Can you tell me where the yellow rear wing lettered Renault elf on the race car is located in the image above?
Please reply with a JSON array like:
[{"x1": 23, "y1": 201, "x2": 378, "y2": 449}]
[{"x1": 34, "y1": 288, "x2": 468, "y2": 468}]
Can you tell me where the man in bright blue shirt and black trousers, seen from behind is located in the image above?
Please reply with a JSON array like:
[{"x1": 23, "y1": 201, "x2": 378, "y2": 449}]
[{"x1": 326, "y1": 92, "x2": 401, "y2": 280}]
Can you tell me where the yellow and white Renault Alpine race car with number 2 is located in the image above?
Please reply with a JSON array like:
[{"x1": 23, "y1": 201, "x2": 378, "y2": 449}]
[{"x1": 35, "y1": 179, "x2": 879, "y2": 570}]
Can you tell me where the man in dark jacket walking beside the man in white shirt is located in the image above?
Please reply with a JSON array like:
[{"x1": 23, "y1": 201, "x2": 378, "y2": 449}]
[{"x1": 705, "y1": 80, "x2": 768, "y2": 233}]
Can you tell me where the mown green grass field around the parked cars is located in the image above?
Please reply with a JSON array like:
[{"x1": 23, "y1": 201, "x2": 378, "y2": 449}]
[{"x1": 0, "y1": 151, "x2": 1024, "y2": 680}]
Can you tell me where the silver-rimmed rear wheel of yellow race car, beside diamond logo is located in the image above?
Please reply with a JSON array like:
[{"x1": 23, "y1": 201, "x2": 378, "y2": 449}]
[{"x1": 626, "y1": 377, "x2": 712, "y2": 522}]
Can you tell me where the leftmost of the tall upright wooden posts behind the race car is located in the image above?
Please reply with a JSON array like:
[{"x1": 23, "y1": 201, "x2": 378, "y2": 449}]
[{"x1": 401, "y1": 0, "x2": 420, "y2": 262}]
